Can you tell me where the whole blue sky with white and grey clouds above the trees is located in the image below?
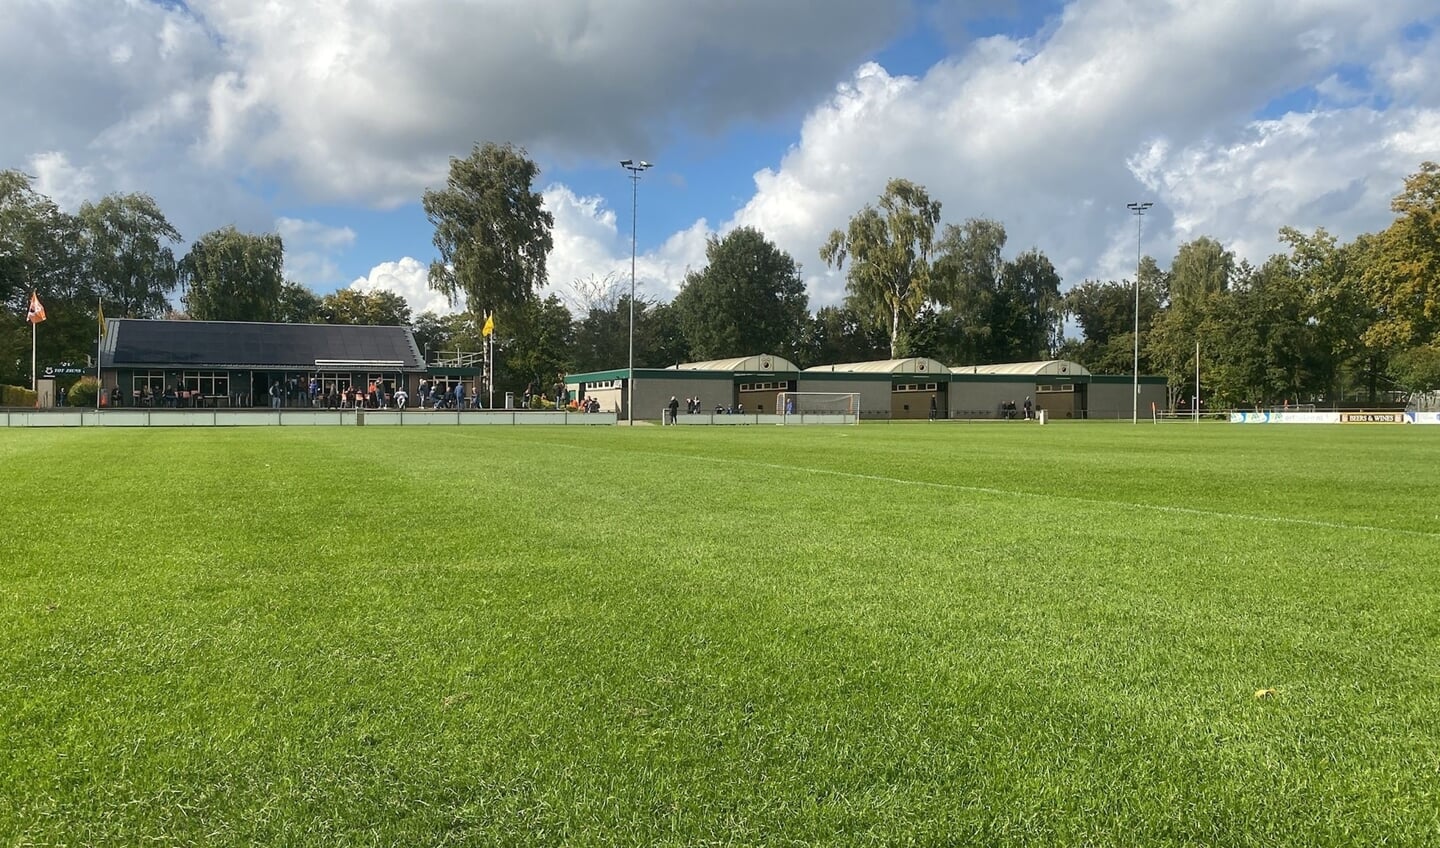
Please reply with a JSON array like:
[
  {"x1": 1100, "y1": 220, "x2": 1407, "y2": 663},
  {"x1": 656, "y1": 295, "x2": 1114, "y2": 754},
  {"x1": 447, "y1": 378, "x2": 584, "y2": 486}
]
[{"x1": 0, "y1": 0, "x2": 1440, "y2": 319}]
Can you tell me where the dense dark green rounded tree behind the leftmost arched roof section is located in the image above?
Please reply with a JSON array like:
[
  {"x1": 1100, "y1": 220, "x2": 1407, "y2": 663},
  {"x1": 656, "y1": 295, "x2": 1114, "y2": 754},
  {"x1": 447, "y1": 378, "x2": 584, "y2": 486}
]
[{"x1": 674, "y1": 227, "x2": 809, "y2": 360}]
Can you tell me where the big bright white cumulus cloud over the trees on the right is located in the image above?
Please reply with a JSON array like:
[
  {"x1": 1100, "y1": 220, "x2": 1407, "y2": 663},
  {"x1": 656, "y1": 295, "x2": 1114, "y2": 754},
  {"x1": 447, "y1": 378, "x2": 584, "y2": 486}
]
[{"x1": 721, "y1": 0, "x2": 1440, "y2": 304}]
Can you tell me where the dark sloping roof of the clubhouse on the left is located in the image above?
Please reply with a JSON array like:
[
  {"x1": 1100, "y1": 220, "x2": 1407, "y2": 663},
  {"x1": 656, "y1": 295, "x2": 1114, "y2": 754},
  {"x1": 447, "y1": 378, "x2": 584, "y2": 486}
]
[{"x1": 101, "y1": 318, "x2": 425, "y2": 370}]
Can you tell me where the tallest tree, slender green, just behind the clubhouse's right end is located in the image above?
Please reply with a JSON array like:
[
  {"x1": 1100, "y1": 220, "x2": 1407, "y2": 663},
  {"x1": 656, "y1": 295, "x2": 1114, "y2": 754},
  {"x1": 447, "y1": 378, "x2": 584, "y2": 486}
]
[{"x1": 423, "y1": 143, "x2": 554, "y2": 314}]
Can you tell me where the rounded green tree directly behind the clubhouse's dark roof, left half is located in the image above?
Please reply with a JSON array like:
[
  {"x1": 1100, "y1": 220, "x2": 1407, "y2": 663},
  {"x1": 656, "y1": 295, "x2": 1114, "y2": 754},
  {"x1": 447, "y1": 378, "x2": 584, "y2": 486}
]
[{"x1": 180, "y1": 226, "x2": 285, "y2": 321}]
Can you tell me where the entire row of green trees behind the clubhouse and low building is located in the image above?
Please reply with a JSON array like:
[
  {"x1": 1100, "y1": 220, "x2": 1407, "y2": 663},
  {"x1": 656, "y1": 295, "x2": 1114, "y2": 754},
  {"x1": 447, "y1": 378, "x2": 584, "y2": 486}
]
[{"x1": 0, "y1": 144, "x2": 1440, "y2": 406}]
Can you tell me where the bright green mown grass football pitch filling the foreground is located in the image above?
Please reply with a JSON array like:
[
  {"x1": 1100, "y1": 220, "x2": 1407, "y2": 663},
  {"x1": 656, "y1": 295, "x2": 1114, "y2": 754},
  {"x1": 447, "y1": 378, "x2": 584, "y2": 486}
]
[{"x1": 0, "y1": 422, "x2": 1440, "y2": 845}]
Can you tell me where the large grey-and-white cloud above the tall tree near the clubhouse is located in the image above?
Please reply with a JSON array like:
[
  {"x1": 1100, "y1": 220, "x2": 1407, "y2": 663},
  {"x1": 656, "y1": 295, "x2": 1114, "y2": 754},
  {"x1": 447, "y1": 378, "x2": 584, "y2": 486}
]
[{"x1": 174, "y1": 0, "x2": 910, "y2": 202}]
